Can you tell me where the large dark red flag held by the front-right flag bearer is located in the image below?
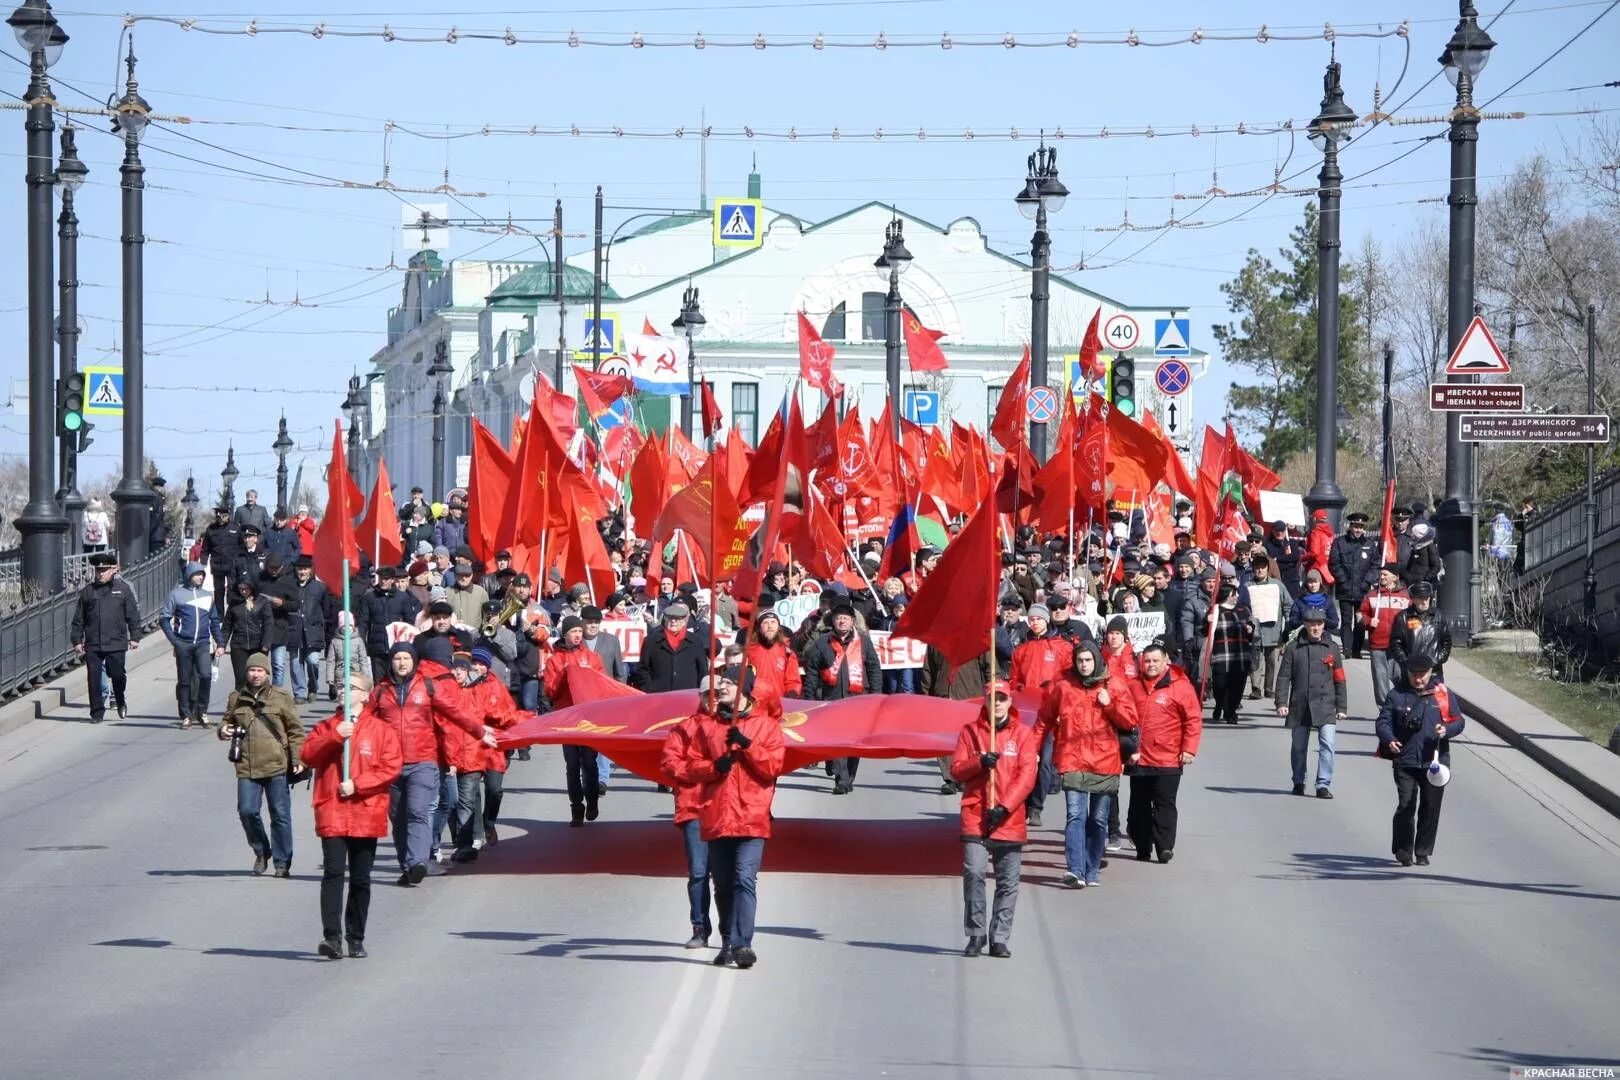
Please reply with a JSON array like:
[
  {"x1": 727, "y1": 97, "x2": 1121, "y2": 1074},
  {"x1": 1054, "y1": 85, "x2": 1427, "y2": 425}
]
[{"x1": 894, "y1": 488, "x2": 1001, "y2": 667}]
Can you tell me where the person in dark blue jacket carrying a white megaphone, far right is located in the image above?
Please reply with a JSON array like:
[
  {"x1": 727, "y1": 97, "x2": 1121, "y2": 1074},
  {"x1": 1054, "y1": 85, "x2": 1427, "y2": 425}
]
[{"x1": 1377, "y1": 653, "x2": 1464, "y2": 866}]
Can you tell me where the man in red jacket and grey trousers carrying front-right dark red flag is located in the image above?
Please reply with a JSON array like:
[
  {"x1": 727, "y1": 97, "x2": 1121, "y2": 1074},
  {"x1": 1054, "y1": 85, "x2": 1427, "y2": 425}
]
[{"x1": 951, "y1": 678, "x2": 1040, "y2": 959}]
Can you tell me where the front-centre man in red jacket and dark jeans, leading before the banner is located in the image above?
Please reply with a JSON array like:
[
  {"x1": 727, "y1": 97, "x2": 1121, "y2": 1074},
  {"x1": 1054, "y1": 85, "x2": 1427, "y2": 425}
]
[{"x1": 676, "y1": 665, "x2": 782, "y2": 968}]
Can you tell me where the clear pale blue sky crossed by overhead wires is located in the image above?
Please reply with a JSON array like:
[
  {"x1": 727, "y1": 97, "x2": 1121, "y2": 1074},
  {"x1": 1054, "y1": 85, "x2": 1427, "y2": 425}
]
[{"x1": 0, "y1": 0, "x2": 1620, "y2": 508}]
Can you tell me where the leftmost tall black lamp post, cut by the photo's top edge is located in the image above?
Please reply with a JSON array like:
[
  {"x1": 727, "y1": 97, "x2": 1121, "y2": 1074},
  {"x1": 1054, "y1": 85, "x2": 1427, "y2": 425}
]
[{"x1": 6, "y1": 0, "x2": 68, "y2": 594}]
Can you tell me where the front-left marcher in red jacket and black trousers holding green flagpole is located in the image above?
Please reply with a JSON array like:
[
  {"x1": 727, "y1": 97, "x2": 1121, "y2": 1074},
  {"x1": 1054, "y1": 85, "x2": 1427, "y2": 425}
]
[{"x1": 298, "y1": 672, "x2": 405, "y2": 960}]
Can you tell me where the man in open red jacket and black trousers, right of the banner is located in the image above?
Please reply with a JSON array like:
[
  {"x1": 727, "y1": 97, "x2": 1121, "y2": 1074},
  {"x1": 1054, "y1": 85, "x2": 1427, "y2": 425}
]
[{"x1": 1126, "y1": 641, "x2": 1204, "y2": 863}]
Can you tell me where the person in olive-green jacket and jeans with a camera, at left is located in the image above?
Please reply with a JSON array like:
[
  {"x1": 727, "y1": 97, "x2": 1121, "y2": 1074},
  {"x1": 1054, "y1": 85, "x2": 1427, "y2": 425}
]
[{"x1": 219, "y1": 651, "x2": 305, "y2": 878}]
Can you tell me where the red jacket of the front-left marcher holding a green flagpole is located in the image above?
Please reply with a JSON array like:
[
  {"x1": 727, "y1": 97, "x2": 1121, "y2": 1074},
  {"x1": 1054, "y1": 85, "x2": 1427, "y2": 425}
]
[{"x1": 298, "y1": 706, "x2": 405, "y2": 837}]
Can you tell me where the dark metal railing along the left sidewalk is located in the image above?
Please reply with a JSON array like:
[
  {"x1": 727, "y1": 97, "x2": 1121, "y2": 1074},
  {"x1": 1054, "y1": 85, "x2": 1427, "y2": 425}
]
[{"x1": 0, "y1": 541, "x2": 180, "y2": 698}]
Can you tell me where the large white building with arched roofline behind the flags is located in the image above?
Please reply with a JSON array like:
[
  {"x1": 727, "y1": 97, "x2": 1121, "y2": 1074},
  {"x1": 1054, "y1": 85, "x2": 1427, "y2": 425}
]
[{"x1": 368, "y1": 175, "x2": 1209, "y2": 494}]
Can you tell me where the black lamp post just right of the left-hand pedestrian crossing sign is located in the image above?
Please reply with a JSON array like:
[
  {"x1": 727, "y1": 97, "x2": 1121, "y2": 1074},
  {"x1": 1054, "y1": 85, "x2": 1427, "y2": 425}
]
[{"x1": 112, "y1": 37, "x2": 157, "y2": 567}]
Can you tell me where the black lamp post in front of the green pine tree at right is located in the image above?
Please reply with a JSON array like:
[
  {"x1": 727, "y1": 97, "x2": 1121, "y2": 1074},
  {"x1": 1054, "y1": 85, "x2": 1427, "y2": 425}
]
[{"x1": 1306, "y1": 60, "x2": 1356, "y2": 531}]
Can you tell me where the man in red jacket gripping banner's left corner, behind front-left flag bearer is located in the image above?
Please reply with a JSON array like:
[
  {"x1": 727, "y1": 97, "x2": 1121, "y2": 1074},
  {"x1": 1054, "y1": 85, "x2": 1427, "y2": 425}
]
[{"x1": 368, "y1": 638, "x2": 496, "y2": 886}]
